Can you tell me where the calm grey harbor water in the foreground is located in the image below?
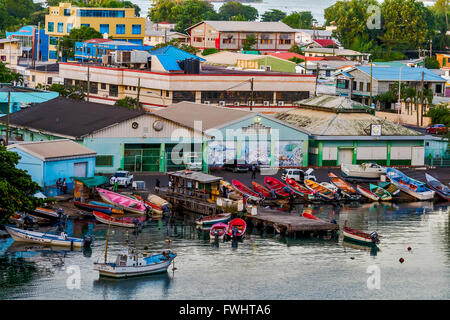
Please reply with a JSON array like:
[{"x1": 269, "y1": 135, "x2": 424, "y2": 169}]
[{"x1": 0, "y1": 202, "x2": 450, "y2": 300}]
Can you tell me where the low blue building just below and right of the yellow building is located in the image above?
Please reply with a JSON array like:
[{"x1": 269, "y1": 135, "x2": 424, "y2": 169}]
[{"x1": 75, "y1": 39, "x2": 153, "y2": 62}]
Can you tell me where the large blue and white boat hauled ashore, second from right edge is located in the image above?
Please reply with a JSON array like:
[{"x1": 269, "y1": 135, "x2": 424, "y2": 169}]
[{"x1": 386, "y1": 168, "x2": 435, "y2": 200}]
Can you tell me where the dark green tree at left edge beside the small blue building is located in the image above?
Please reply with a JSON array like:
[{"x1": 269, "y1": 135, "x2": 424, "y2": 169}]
[{"x1": 0, "y1": 146, "x2": 42, "y2": 224}]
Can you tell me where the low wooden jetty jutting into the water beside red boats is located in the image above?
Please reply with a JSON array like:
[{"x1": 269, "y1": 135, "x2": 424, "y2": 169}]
[{"x1": 243, "y1": 207, "x2": 339, "y2": 237}]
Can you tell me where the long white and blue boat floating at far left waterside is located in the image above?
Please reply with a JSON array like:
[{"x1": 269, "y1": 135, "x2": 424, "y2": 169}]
[{"x1": 5, "y1": 226, "x2": 89, "y2": 247}]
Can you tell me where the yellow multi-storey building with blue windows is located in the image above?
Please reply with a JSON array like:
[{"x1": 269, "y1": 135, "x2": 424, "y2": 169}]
[{"x1": 45, "y1": 3, "x2": 145, "y2": 61}]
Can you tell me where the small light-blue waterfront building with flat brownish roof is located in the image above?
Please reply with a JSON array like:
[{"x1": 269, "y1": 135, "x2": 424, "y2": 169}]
[{"x1": 7, "y1": 139, "x2": 97, "y2": 196}]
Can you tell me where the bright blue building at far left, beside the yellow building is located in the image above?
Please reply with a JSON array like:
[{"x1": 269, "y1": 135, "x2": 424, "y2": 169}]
[{"x1": 6, "y1": 26, "x2": 49, "y2": 61}]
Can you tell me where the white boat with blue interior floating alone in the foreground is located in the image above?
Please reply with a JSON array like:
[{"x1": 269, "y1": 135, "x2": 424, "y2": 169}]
[{"x1": 94, "y1": 248, "x2": 177, "y2": 278}]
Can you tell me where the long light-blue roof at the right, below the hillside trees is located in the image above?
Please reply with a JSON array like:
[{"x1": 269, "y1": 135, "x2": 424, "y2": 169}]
[{"x1": 356, "y1": 65, "x2": 445, "y2": 82}]
